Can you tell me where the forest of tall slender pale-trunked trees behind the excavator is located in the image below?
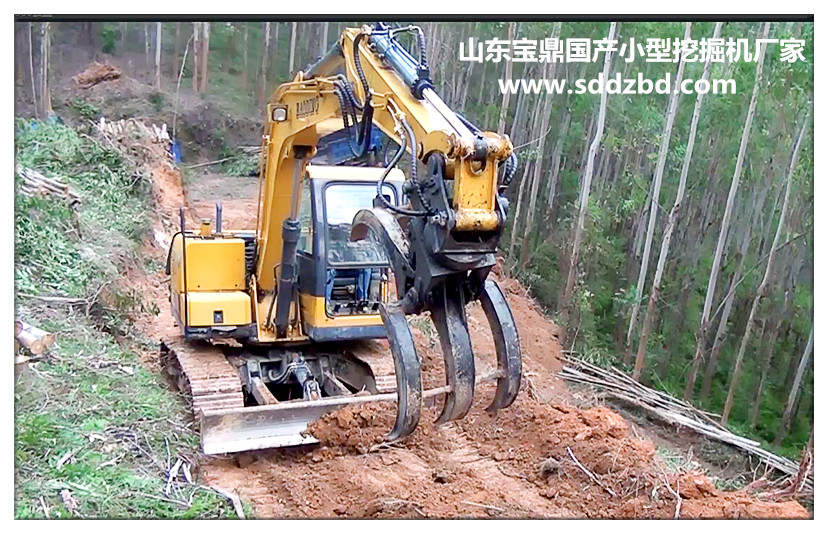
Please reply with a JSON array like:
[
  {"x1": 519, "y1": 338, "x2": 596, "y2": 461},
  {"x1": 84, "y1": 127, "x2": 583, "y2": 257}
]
[{"x1": 15, "y1": 21, "x2": 815, "y2": 457}]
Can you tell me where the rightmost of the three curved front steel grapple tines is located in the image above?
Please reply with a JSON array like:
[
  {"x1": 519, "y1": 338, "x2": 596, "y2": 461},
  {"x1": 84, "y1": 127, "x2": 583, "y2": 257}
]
[{"x1": 480, "y1": 280, "x2": 521, "y2": 412}]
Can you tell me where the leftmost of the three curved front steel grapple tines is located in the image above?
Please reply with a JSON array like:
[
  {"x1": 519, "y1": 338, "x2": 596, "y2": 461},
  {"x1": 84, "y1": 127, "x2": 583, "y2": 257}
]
[{"x1": 380, "y1": 303, "x2": 423, "y2": 441}]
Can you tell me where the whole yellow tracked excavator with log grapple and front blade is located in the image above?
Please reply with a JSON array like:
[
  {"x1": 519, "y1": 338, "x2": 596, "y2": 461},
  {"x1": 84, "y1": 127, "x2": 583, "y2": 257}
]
[{"x1": 161, "y1": 23, "x2": 521, "y2": 454}]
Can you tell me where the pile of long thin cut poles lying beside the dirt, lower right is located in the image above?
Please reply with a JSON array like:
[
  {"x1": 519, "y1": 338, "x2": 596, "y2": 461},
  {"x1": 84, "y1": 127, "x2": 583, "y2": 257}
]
[{"x1": 558, "y1": 355, "x2": 814, "y2": 493}]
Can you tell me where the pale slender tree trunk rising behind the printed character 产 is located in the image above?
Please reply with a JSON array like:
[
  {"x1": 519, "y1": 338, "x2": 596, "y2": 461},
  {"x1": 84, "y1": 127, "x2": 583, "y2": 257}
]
[{"x1": 562, "y1": 22, "x2": 616, "y2": 326}]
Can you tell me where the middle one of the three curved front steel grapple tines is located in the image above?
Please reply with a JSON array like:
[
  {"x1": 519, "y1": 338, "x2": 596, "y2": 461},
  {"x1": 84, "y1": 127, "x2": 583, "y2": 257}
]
[{"x1": 431, "y1": 279, "x2": 474, "y2": 424}]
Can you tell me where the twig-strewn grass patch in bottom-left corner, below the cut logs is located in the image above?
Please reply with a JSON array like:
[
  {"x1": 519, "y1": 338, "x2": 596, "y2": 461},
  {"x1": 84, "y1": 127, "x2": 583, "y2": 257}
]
[{"x1": 15, "y1": 324, "x2": 233, "y2": 518}]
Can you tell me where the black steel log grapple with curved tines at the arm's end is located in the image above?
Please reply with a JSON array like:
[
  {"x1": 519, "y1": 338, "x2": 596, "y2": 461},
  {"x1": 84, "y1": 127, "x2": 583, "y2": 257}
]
[{"x1": 351, "y1": 199, "x2": 521, "y2": 440}]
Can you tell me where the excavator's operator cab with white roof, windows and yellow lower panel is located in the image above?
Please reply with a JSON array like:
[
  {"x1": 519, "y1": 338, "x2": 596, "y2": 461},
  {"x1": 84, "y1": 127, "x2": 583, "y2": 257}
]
[{"x1": 296, "y1": 164, "x2": 404, "y2": 342}]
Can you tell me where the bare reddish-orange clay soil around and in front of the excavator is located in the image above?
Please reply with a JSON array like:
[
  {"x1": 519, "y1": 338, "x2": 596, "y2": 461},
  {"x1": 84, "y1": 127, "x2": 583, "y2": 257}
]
[{"x1": 135, "y1": 162, "x2": 808, "y2": 518}]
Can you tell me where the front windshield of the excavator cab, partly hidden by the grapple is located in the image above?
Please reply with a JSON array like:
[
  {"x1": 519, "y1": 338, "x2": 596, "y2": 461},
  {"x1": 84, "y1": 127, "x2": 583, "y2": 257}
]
[{"x1": 325, "y1": 184, "x2": 397, "y2": 265}]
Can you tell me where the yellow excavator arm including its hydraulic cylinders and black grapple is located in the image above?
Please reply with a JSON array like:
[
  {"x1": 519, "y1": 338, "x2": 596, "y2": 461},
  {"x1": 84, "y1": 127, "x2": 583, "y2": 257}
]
[{"x1": 256, "y1": 24, "x2": 521, "y2": 439}]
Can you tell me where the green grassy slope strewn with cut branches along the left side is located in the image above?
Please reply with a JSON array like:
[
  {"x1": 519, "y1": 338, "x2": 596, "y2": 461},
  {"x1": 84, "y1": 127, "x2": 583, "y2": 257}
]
[{"x1": 15, "y1": 121, "x2": 234, "y2": 518}]
